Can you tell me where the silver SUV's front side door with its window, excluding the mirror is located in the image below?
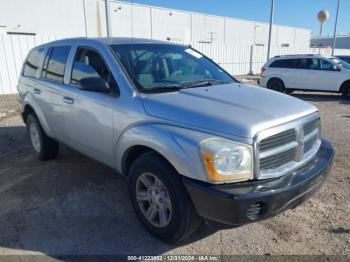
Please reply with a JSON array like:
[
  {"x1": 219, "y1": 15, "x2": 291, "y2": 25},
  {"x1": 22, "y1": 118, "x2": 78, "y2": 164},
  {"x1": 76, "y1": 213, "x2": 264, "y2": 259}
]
[{"x1": 66, "y1": 47, "x2": 117, "y2": 164}]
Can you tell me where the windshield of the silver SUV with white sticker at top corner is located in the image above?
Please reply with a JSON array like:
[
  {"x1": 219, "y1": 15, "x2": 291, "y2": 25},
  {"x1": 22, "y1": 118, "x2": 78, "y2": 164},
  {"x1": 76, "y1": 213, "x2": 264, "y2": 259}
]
[{"x1": 111, "y1": 44, "x2": 235, "y2": 92}]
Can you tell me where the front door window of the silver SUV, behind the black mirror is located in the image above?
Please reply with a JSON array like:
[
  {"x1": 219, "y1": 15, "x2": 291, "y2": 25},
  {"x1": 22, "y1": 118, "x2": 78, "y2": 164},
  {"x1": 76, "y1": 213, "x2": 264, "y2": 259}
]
[{"x1": 70, "y1": 47, "x2": 117, "y2": 88}]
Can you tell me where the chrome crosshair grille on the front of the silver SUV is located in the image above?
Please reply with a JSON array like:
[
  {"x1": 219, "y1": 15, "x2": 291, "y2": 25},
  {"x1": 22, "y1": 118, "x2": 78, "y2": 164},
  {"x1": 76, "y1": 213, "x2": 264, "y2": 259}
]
[{"x1": 255, "y1": 114, "x2": 321, "y2": 179}]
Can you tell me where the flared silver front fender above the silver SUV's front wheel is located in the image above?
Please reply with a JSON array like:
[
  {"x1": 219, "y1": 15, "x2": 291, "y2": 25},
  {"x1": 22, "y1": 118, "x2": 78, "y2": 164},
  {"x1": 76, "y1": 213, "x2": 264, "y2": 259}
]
[{"x1": 116, "y1": 122, "x2": 213, "y2": 181}]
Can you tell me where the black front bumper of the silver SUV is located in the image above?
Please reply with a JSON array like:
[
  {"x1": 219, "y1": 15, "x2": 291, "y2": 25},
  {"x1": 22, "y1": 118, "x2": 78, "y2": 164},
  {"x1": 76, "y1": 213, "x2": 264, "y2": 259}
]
[{"x1": 183, "y1": 140, "x2": 334, "y2": 226}]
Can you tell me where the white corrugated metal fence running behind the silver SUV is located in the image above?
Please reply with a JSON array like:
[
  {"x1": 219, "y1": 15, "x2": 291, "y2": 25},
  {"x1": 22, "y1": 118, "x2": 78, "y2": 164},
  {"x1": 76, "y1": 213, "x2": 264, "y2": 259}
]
[{"x1": 0, "y1": 33, "x2": 350, "y2": 95}]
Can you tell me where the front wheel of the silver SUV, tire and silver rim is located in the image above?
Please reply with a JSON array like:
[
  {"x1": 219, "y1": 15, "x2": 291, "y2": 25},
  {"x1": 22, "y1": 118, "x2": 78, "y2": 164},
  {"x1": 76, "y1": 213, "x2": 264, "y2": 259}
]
[{"x1": 129, "y1": 153, "x2": 202, "y2": 243}]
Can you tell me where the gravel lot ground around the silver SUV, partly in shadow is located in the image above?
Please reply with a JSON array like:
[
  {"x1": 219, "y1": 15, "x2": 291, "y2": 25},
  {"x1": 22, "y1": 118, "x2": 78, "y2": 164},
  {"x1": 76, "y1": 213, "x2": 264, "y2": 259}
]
[{"x1": 0, "y1": 89, "x2": 350, "y2": 258}]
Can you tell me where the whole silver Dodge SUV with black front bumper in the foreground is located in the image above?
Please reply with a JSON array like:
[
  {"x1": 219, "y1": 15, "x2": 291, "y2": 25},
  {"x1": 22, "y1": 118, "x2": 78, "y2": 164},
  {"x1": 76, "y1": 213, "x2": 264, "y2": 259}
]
[{"x1": 18, "y1": 38, "x2": 333, "y2": 242}]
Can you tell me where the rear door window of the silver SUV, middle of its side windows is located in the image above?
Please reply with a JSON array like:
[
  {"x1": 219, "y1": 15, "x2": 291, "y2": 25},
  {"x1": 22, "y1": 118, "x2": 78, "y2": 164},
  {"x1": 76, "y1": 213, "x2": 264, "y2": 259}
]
[{"x1": 41, "y1": 46, "x2": 70, "y2": 83}]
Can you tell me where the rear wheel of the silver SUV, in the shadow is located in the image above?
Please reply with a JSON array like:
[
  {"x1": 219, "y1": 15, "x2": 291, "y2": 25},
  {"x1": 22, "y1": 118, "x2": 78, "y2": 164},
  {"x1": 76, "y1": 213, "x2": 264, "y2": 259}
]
[{"x1": 26, "y1": 114, "x2": 59, "y2": 160}]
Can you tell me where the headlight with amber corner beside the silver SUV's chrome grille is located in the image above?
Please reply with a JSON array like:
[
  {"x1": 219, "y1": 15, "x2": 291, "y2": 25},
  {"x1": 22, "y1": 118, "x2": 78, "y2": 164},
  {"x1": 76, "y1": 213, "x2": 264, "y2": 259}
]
[{"x1": 200, "y1": 139, "x2": 253, "y2": 183}]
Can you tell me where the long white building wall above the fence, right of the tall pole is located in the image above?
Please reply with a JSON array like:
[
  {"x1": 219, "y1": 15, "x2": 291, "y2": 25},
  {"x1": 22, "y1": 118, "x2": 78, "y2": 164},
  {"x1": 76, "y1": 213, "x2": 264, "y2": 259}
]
[{"x1": 110, "y1": 1, "x2": 310, "y2": 47}]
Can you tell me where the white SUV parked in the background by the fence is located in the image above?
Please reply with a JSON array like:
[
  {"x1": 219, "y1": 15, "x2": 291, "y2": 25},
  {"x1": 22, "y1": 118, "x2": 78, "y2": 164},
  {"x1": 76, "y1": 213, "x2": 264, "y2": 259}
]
[{"x1": 259, "y1": 55, "x2": 350, "y2": 98}]
